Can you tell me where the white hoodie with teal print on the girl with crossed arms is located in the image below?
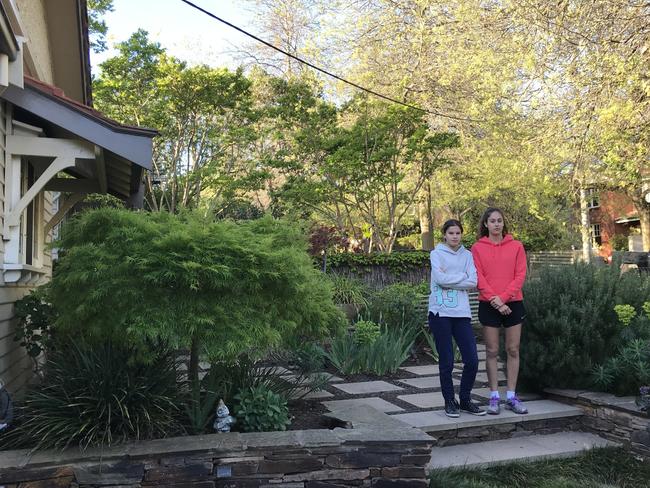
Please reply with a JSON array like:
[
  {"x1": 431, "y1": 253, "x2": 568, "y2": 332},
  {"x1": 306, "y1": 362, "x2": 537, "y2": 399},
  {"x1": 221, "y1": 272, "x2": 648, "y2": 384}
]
[{"x1": 429, "y1": 244, "x2": 476, "y2": 318}]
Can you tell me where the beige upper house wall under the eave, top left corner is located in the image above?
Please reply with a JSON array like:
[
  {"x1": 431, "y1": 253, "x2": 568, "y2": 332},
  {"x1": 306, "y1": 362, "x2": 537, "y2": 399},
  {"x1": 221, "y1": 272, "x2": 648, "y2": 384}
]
[{"x1": 16, "y1": 0, "x2": 54, "y2": 84}]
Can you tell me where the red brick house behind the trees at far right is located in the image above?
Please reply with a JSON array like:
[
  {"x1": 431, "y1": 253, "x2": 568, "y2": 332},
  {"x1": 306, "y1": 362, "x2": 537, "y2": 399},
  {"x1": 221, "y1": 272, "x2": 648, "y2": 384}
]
[{"x1": 587, "y1": 189, "x2": 643, "y2": 257}]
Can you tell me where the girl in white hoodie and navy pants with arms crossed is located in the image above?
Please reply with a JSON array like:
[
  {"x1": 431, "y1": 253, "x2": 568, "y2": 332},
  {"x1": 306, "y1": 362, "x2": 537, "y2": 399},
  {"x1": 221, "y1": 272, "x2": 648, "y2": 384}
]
[{"x1": 429, "y1": 219, "x2": 485, "y2": 417}]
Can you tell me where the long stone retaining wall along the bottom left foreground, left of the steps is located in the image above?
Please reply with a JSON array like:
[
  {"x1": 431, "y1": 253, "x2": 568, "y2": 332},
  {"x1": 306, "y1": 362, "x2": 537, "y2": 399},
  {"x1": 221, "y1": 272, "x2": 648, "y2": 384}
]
[{"x1": 0, "y1": 407, "x2": 435, "y2": 488}]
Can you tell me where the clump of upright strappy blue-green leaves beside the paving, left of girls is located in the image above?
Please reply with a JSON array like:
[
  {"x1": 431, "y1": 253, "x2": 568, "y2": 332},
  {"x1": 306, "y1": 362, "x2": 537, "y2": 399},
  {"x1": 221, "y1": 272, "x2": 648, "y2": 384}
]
[{"x1": 327, "y1": 327, "x2": 419, "y2": 376}]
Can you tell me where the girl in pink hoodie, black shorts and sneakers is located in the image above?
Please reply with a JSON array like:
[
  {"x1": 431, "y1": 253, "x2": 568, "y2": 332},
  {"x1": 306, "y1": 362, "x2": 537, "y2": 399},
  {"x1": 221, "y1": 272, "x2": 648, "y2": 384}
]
[{"x1": 472, "y1": 207, "x2": 528, "y2": 415}]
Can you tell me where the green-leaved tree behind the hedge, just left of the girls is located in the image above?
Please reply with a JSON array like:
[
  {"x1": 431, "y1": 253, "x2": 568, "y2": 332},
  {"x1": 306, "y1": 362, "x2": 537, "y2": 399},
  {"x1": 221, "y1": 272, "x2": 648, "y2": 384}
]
[{"x1": 276, "y1": 98, "x2": 459, "y2": 252}]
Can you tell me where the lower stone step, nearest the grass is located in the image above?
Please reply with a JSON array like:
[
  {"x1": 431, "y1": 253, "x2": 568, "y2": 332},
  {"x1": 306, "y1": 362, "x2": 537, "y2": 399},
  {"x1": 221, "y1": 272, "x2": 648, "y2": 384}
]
[{"x1": 427, "y1": 432, "x2": 617, "y2": 472}]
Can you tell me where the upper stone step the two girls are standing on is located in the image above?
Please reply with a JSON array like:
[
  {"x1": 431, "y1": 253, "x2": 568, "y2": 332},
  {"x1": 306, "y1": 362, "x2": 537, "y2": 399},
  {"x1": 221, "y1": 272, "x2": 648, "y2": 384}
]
[{"x1": 393, "y1": 400, "x2": 583, "y2": 432}]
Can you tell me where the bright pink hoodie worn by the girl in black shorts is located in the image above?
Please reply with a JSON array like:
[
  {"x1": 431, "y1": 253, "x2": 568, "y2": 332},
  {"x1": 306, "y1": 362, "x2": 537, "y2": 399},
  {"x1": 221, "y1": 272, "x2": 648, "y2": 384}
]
[{"x1": 472, "y1": 234, "x2": 526, "y2": 303}]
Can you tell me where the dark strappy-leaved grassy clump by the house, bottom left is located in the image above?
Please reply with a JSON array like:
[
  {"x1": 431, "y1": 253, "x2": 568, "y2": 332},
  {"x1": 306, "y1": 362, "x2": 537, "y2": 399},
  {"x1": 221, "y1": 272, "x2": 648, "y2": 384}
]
[{"x1": 2, "y1": 337, "x2": 179, "y2": 449}]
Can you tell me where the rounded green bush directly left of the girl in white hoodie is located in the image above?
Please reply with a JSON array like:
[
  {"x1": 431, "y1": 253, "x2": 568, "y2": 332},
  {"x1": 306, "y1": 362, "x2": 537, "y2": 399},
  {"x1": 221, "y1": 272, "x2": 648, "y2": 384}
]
[{"x1": 368, "y1": 283, "x2": 428, "y2": 330}]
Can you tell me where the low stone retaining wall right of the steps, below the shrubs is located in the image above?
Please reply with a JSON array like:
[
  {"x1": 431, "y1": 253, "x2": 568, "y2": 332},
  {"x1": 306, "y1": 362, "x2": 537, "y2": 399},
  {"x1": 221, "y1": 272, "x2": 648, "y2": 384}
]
[{"x1": 545, "y1": 388, "x2": 650, "y2": 458}]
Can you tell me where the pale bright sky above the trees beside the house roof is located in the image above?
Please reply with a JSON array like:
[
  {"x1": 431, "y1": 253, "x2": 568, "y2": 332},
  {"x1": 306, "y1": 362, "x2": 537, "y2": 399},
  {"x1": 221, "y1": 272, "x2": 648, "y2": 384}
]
[{"x1": 91, "y1": 0, "x2": 255, "y2": 72}]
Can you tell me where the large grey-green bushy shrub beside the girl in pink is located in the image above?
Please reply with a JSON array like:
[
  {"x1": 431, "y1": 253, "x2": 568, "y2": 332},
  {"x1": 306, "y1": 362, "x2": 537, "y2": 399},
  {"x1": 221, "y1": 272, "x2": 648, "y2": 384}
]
[{"x1": 520, "y1": 263, "x2": 650, "y2": 390}]
